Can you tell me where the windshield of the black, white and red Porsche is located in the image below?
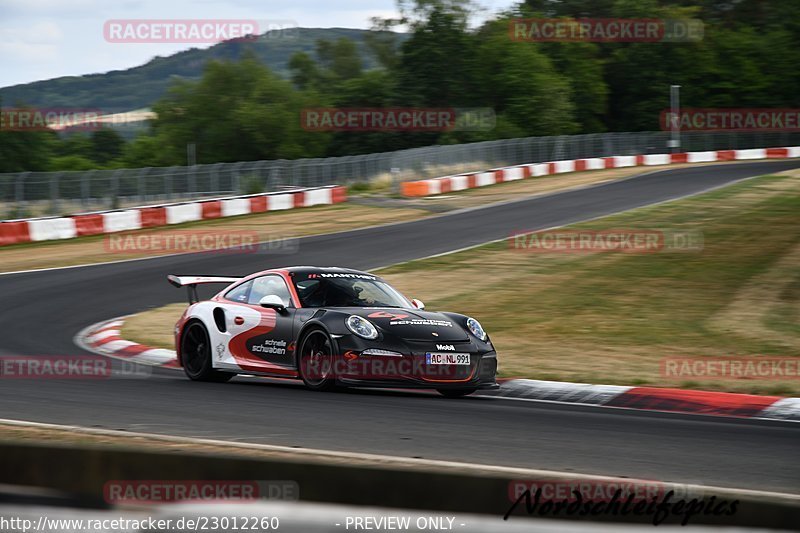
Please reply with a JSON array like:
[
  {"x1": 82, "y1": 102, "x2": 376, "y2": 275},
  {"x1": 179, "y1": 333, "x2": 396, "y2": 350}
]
[{"x1": 293, "y1": 274, "x2": 411, "y2": 307}]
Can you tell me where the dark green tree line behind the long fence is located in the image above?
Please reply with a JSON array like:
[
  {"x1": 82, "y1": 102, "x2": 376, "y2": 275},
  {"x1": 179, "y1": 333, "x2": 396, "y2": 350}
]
[{"x1": 0, "y1": 0, "x2": 800, "y2": 172}]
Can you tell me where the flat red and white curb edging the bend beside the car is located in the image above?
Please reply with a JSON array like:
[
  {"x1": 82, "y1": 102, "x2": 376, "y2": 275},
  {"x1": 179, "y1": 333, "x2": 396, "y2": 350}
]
[{"x1": 75, "y1": 317, "x2": 800, "y2": 422}]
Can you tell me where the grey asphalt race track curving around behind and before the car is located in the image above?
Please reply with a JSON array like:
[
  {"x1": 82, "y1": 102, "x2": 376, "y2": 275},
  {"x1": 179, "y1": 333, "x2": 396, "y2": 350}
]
[{"x1": 0, "y1": 160, "x2": 800, "y2": 493}]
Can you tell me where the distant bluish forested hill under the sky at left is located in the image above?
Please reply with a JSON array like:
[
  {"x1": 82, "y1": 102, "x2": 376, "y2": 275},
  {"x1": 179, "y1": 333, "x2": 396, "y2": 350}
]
[{"x1": 0, "y1": 28, "x2": 405, "y2": 111}]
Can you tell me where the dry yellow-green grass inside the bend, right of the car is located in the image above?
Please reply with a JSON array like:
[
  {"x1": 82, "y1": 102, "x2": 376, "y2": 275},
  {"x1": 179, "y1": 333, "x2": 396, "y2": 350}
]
[{"x1": 381, "y1": 171, "x2": 800, "y2": 395}]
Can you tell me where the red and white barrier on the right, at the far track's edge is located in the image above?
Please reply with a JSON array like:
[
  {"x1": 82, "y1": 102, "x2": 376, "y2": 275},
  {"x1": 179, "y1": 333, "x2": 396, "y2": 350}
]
[{"x1": 401, "y1": 146, "x2": 800, "y2": 196}]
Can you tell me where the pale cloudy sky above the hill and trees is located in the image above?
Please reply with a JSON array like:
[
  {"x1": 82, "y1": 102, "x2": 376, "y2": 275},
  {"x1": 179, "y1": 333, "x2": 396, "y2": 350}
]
[{"x1": 0, "y1": 0, "x2": 514, "y2": 87}]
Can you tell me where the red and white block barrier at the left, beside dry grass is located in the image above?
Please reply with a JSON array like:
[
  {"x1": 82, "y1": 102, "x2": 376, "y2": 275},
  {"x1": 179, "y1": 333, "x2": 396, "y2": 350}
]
[{"x1": 0, "y1": 185, "x2": 347, "y2": 246}]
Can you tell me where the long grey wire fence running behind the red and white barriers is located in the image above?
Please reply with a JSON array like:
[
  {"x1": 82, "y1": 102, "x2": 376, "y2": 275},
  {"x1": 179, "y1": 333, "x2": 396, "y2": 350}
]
[{"x1": 0, "y1": 131, "x2": 800, "y2": 219}]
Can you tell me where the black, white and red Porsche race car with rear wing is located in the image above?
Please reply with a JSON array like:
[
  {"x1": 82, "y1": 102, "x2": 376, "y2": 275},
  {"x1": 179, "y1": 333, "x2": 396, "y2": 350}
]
[{"x1": 167, "y1": 266, "x2": 498, "y2": 397}]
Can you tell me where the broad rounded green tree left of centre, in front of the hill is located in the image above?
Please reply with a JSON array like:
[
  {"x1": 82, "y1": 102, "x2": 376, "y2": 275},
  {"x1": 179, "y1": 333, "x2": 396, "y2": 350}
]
[{"x1": 153, "y1": 56, "x2": 326, "y2": 164}]
